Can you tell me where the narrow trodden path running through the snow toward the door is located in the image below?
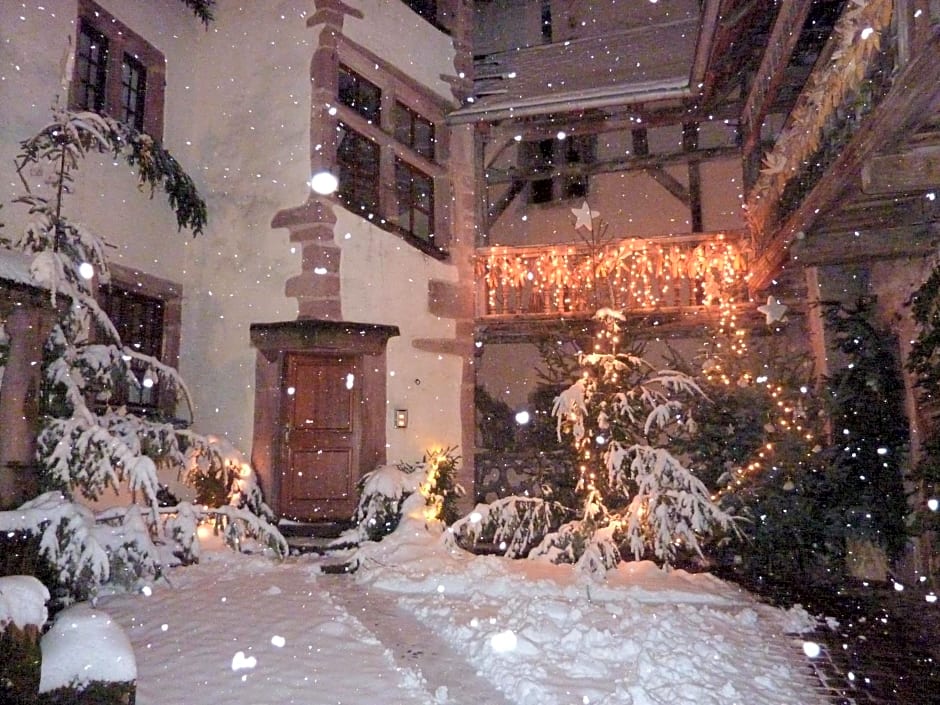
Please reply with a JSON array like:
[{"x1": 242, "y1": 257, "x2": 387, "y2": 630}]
[{"x1": 320, "y1": 575, "x2": 511, "y2": 705}]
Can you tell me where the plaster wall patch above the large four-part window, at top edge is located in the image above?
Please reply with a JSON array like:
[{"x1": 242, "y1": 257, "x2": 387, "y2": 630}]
[{"x1": 343, "y1": 0, "x2": 457, "y2": 102}]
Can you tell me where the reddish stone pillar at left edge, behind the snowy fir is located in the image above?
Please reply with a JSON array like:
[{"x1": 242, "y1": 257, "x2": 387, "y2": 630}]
[{"x1": 0, "y1": 305, "x2": 54, "y2": 509}]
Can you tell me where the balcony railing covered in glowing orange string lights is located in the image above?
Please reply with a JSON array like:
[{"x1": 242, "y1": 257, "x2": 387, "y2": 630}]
[{"x1": 476, "y1": 232, "x2": 747, "y2": 319}]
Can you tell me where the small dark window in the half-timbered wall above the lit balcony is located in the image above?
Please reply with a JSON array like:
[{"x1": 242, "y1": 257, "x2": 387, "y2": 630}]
[{"x1": 523, "y1": 135, "x2": 595, "y2": 203}]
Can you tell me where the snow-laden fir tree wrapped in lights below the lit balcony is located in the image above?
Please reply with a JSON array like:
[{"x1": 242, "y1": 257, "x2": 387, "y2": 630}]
[{"x1": 452, "y1": 309, "x2": 735, "y2": 573}]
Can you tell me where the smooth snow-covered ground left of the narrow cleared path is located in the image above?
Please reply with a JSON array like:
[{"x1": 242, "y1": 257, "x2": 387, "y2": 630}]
[{"x1": 99, "y1": 558, "x2": 435, "y2": 705}]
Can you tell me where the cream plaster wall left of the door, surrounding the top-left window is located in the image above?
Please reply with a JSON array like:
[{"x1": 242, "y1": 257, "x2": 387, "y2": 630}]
[{"x1": 0, "y1": 0, "x2": 316, "y2": 451}]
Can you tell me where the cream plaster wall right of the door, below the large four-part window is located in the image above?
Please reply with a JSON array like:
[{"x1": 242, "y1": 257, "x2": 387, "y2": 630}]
[{"x1": 335, "y1": 207, "x2": 462, "y2": 462}]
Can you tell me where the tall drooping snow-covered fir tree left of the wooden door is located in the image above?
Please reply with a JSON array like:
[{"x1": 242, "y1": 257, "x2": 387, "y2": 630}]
[{"x1": 0, "y1": 99, "x2": 286, "y2": 597}]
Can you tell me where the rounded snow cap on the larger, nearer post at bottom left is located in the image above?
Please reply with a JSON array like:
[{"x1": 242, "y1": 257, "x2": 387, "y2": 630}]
[{"x1": 39, "y1": 603, "x2": 137, "y2": 693}]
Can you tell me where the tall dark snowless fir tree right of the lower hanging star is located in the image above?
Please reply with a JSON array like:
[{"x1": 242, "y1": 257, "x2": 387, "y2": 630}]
[{"x1": 824, "y1": 301, "x2": 908, "y2": 558}]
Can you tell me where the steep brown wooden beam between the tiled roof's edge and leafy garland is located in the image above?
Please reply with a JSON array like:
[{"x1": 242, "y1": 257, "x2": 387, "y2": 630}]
[{"x1": 741, "y1": 0, "x2": 813, "y2": 153}]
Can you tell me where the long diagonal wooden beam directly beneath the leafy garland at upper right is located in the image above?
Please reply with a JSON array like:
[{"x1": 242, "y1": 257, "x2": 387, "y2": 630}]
[{"x1": 748, "y1": 28, "x2": 940, "y2": 294}]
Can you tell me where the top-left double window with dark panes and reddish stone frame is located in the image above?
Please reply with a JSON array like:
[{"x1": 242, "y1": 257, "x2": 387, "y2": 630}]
[{"x1": 69, "y1": 0, "x2": 166, "y2": 139}]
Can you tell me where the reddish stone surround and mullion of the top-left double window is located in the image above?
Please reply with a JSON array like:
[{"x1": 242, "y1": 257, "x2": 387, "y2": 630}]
[{"x1": 69, "y1": 0, "x2": 166, "y2": 140}]
